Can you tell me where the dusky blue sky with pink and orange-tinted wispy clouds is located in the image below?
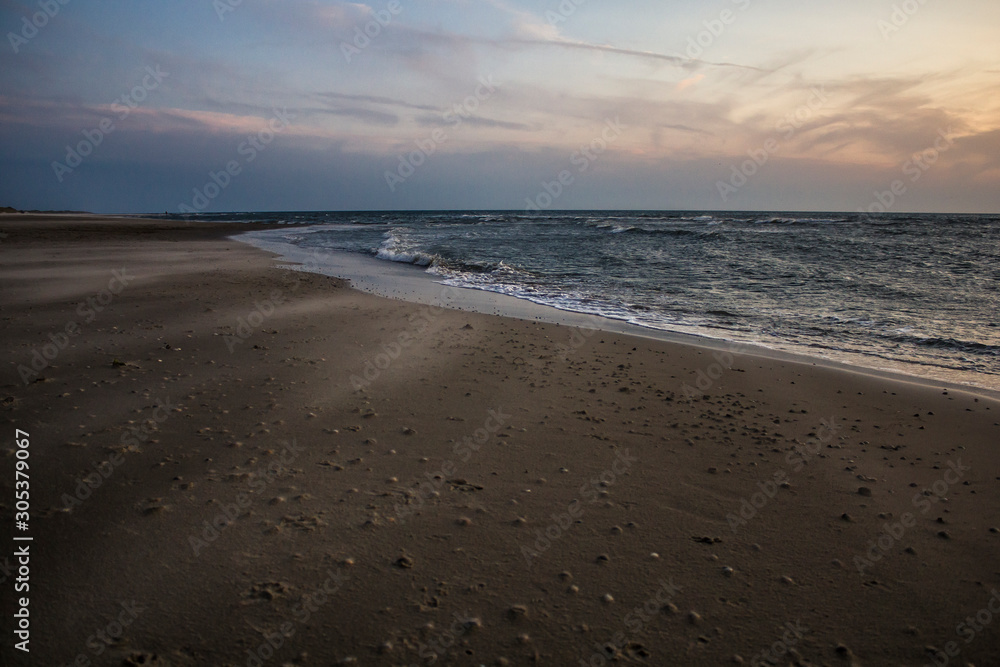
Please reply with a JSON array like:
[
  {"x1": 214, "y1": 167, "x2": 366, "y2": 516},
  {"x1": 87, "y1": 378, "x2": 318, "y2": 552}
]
[{"x1": 0, "y1": 0, "x2": 1000, "y2": 213}]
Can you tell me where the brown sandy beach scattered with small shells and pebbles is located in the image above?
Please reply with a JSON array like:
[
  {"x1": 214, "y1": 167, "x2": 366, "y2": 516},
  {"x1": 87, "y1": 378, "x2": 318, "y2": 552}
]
[{"x1": 0, "y1": 215, "x2": 1000, "y2": 666}]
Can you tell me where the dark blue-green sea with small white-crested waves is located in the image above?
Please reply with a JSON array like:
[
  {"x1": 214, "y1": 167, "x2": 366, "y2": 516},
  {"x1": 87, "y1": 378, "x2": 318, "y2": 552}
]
[{"x1": 169, "y1": 211, "x2": 1000, "y2": 391}]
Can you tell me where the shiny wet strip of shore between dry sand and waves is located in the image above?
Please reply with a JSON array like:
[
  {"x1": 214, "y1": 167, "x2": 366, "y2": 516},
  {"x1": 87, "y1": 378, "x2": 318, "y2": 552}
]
[{"x1": 229, "y1": 223, "x2": 1000, "y2": 400}]
